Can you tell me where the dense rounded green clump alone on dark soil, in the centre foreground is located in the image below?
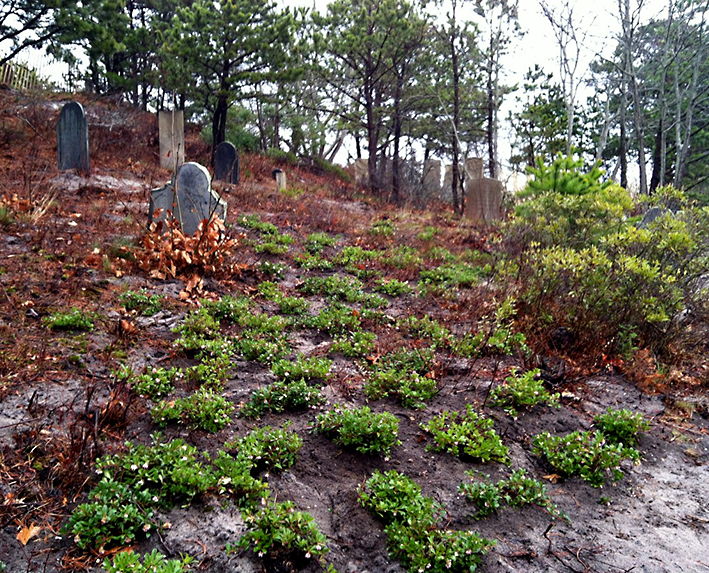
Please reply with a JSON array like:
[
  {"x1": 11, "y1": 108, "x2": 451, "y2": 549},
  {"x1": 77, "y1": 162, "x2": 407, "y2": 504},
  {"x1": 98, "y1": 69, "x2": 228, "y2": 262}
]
[{"x1": 313, "y1": 404, "x2": 401, "y2": 455}]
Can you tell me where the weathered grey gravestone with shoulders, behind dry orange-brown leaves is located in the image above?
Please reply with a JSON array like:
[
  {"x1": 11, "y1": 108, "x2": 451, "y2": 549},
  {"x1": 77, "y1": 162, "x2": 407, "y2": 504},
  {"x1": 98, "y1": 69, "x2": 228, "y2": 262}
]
[{"x1": 150, "y1": 163, "x2": 227, "y2": 235}]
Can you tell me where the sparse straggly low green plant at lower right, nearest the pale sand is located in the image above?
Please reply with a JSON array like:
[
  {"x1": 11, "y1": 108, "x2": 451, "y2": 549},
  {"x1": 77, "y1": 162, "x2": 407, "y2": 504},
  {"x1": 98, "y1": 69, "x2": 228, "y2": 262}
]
[{"x1": 460, "y1": 470, "x2": 562, "y2": 519}]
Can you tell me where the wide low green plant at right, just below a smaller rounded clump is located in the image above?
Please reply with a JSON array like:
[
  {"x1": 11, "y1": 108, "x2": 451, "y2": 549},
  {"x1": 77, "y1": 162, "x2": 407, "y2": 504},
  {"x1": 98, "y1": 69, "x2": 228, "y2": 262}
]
[{"x1": 532, "y1": 430, "x2": 640, "y2": 487}]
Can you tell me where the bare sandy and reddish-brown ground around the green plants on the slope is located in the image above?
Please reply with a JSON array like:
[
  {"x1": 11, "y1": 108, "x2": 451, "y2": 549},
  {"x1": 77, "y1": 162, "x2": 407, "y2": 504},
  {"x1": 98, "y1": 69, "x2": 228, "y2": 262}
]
[{"x1": 0, "y1": 92, "x2": 709, "y2": 573}]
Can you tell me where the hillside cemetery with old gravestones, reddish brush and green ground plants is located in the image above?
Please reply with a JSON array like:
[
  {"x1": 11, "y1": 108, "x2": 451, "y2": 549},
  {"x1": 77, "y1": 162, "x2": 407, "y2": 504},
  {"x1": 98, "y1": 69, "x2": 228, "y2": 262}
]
[{"x1": 0, "y1": 86, "x2": 709, "y2": 573}]
